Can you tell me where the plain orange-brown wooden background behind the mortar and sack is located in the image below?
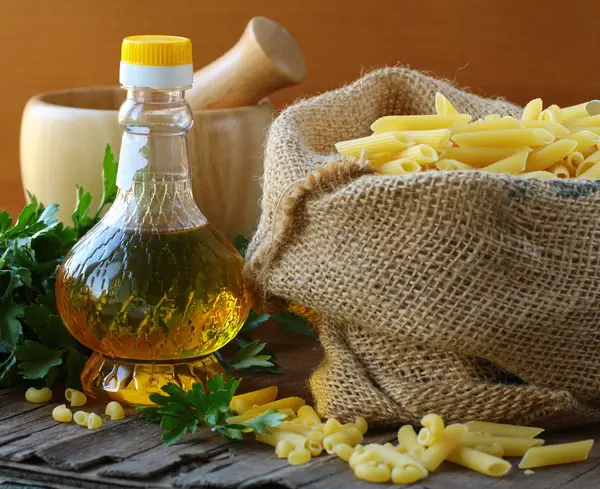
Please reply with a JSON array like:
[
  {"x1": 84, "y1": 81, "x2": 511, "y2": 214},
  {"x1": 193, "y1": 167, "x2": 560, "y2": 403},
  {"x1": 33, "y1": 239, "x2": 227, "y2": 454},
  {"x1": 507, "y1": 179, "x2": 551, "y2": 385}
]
[{"x1": 0, "y1": 0, "x2": 600, "y2": 213}]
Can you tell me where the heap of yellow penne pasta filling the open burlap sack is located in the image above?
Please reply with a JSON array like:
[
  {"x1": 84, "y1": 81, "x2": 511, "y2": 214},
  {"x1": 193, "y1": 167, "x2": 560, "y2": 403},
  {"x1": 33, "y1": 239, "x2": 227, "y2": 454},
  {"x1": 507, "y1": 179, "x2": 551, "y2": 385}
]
[{"x1": 336, "y1": 93, "x2": 600, "y2": 180}]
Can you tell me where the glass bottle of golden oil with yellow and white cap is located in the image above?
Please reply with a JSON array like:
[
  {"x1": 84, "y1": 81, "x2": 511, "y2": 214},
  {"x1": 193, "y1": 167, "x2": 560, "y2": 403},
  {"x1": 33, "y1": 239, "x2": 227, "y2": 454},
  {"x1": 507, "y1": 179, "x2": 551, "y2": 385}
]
[{"x1": 56, "y1": 36, "x2": 250, "y2": 404}]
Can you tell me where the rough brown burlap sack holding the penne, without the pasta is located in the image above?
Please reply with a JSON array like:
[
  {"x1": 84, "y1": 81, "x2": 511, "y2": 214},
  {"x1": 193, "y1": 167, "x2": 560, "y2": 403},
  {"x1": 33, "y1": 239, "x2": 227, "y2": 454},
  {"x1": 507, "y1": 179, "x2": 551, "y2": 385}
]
[{"x1": 246, "y1": 68, "x2": 600, "y2": 427}]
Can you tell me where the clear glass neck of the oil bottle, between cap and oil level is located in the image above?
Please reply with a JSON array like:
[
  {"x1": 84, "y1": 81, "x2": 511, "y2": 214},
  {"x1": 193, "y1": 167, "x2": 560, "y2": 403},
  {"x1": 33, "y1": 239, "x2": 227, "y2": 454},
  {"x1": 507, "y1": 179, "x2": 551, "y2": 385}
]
[{"x1": 106, "y1": 88, "x2": 206, "y2": 231}]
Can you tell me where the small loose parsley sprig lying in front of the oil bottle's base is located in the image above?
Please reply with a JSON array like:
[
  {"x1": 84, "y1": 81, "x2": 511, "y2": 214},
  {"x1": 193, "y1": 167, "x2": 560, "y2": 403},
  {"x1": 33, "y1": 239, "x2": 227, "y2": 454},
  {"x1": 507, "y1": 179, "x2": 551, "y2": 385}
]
[{"x1": 135, "y1": 374, "x2": 287, "y2": 445}]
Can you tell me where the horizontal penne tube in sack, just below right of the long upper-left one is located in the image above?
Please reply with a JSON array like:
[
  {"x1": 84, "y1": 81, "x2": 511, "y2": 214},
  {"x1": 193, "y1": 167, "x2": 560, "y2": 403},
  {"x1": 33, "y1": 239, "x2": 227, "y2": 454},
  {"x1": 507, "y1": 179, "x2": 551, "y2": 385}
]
[{"x1": 452, "y1": 128, "x2": 556, "y2": 148}]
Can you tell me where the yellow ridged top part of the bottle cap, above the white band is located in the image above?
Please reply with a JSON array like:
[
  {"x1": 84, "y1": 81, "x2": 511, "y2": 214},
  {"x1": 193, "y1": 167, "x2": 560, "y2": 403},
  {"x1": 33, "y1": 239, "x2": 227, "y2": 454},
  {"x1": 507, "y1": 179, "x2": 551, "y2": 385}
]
[{"x1": 121, "y1": 35, "x2": 192, "y2": 66}]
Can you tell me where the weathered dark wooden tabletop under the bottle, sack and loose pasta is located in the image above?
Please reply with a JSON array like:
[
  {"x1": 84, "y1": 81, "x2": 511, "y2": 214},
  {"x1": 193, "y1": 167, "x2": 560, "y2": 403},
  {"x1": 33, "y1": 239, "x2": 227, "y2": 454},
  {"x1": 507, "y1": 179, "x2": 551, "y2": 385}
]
[{"x1": 0, "y1": 324, "x2": 600, "y2": 489}]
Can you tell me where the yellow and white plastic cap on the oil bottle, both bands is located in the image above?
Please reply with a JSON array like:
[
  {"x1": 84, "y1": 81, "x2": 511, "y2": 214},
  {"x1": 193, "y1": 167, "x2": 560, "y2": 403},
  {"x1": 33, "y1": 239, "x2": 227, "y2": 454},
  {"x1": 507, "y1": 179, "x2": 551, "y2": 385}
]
[{"x1": 119, "y1": 35, "x2": 194, "y2": 89}]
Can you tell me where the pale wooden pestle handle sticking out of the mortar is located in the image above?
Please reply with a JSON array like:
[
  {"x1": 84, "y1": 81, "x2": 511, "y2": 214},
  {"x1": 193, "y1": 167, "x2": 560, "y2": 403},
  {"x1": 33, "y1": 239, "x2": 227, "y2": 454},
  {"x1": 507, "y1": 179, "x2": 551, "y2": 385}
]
[{"x1": 186, "y1": 17, "x2": 306, "y2": 110}]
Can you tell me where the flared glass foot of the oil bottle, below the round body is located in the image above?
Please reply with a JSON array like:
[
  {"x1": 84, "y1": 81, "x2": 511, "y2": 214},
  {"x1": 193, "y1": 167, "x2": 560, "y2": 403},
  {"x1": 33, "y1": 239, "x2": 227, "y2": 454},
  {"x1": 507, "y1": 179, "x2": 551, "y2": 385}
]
[{"x1": 81, "y1": 353, "x2": 224, "y2": 406}]
